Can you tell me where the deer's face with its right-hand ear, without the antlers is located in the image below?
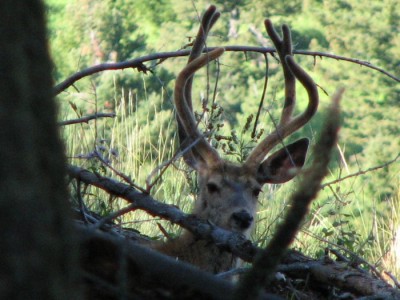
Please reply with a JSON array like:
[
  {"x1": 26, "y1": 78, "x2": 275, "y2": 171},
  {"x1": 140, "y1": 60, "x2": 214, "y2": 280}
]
[{"x1": 193, "y1": 139, "x2": 308, "y2": 237}]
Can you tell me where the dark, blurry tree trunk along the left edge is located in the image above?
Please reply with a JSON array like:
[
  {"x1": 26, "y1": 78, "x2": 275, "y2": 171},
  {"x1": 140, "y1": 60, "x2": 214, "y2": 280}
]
[{"x1": 0, "y1": 0, "x2": 80, "y2": 299}]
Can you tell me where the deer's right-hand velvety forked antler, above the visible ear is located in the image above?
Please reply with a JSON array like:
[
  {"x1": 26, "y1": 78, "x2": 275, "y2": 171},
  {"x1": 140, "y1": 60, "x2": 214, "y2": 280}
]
[{"x1": 245, "y1": 19, "x2": 319, "y2": 166}]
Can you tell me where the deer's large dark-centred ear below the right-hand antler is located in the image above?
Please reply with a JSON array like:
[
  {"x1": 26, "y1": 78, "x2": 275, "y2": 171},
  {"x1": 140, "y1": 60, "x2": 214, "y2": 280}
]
[{"x1": 257, "y1": 138, "x2": 309, "y2": 184}]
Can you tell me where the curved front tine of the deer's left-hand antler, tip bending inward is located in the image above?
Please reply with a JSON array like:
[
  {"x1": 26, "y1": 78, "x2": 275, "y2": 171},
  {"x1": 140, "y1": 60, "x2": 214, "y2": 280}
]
[{"x1": 174, "y1": 48, "x2": 225, "y2": 167}]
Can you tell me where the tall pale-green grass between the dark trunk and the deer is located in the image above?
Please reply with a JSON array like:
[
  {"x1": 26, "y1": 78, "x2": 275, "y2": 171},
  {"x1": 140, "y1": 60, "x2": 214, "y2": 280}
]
[{"x1": 60, "y1": 75, "x2": 193, "y2": 237}]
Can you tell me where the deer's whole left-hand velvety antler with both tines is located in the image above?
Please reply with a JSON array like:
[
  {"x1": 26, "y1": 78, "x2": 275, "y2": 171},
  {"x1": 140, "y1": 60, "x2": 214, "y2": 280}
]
[{"x1": 175, "y1": 6, "x2": 224, "y2": 168}]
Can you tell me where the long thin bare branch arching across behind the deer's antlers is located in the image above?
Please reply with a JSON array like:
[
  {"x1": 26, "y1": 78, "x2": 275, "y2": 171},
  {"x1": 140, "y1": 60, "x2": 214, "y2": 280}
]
[{"x1": 53, "y1": 46, "x2": 400, "y2": 95}]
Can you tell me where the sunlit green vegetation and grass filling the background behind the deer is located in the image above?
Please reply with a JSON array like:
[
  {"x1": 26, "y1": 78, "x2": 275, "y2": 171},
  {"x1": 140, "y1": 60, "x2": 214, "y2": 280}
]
[{"x1": 46, "y1": 0, "x2": 400, "y2": 272}]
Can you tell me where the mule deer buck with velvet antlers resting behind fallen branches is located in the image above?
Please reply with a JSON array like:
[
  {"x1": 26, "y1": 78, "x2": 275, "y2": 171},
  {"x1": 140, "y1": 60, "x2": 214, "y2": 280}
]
[{"x1": 159, "y1": 6, "x2": 318, "y2": 273}]
